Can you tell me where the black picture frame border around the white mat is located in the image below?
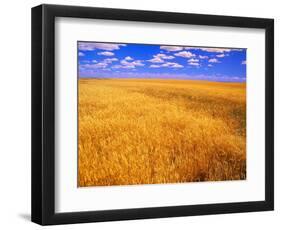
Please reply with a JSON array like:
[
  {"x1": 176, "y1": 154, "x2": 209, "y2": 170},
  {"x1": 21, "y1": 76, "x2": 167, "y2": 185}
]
[{"x1": 31, "y1": 5, "x2": 274, "y2": 225}]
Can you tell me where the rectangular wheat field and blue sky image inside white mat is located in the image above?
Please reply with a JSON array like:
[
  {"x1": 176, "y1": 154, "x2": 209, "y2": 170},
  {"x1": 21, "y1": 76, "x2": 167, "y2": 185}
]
[{"x1": 77, "y1": 41, "x2": 247, "y2": 187}]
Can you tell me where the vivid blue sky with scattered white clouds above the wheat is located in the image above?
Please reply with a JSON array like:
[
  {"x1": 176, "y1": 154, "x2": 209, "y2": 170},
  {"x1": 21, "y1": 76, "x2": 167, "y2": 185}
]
[{"x1": 78, "y1": 42, "x2": 246, "y2": 82}]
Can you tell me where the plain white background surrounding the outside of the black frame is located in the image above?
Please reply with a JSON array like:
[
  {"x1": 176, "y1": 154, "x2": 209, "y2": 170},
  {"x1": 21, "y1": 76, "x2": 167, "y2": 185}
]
[{"x1": 0, "y1": 0, "x2": 276, "y2": 230}]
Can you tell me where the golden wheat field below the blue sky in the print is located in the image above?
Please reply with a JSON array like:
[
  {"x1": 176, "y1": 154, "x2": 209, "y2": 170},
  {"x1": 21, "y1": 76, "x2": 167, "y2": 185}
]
[{"x1": 78, "y1": 79, "x2": 246, "y2": 187}]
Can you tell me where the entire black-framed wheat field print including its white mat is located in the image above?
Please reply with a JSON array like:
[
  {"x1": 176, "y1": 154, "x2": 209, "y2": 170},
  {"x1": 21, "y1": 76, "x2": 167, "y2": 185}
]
[{"x1": 32, "y1": 5, "x2": 274, "y2": 225}]
